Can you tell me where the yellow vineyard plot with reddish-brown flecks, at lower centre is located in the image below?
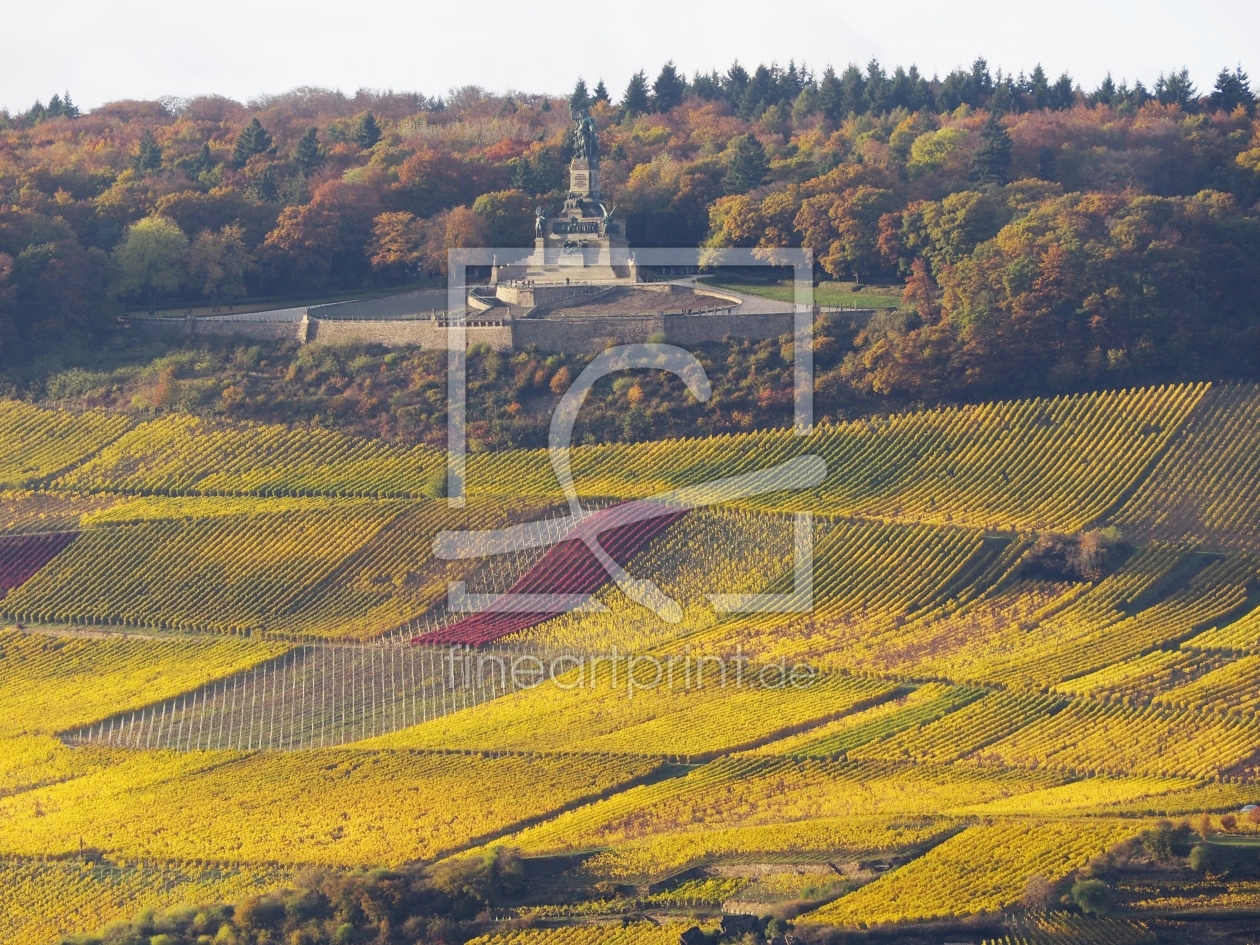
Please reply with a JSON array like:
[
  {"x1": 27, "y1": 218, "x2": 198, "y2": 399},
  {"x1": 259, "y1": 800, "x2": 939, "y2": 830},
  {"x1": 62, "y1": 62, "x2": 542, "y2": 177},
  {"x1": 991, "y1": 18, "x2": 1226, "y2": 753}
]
[{"x1": 488, "y1": 756, "x2": 1062, "y2": 879}]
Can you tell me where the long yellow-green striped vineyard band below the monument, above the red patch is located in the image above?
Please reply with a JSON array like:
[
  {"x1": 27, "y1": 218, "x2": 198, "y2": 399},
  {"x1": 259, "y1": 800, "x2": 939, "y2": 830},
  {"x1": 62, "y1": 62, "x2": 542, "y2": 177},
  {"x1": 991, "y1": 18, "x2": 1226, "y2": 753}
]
[{"x1": 469, "y1": 384, "x2": 1207, "y2": 530}]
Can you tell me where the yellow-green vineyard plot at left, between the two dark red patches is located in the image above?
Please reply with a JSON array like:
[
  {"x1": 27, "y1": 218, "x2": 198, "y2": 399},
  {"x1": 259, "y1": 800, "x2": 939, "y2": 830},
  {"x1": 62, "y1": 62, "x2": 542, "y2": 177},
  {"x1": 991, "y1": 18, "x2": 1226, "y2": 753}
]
[{"x1": 0, "y1": 499, "x2": 556, "y2": 638}]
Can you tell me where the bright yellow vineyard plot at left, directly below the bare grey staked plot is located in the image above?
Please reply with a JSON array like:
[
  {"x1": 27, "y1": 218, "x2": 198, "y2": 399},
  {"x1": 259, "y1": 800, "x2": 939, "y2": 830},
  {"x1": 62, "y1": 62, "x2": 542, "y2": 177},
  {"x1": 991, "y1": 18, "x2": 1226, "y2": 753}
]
[{"x1": 0, "y1": 750, "x2": 656, "y2": 867}]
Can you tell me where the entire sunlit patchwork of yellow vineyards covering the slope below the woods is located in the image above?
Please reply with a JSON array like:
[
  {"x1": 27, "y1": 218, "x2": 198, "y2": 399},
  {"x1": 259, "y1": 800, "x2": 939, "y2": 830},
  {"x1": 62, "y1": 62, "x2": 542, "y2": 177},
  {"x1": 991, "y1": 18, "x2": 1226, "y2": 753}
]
[{"x1": 7, "y1": 384, "x2": 1260, "y2": 945}]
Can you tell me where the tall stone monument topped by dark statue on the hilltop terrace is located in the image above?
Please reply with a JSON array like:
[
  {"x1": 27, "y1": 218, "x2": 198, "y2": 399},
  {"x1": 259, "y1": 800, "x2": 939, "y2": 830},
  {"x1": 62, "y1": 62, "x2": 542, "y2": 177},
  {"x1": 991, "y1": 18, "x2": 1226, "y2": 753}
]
[{"x1": 493, "y1": 108, "x2": 639, "y2": 282}]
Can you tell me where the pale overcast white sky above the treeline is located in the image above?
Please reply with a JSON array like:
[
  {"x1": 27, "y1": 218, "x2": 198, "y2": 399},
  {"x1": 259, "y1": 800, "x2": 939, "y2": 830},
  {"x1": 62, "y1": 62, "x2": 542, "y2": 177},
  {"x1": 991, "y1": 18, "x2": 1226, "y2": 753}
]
[{"x1": 0, "y1": 0, "x2": 1260, "y2": 111}]
